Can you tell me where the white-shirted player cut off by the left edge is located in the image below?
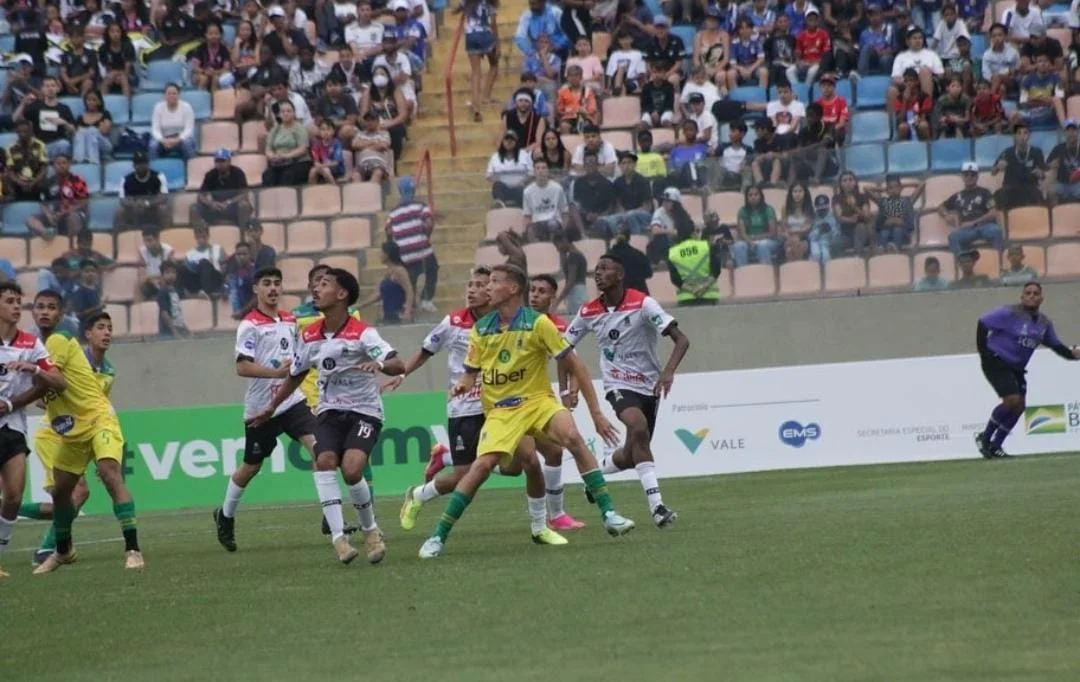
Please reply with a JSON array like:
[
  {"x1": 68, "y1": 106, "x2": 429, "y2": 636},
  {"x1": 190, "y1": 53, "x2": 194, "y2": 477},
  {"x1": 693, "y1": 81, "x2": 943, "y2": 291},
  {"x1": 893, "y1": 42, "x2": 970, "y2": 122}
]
[{"x1": 0, "y1": 282, "x2": 67, "y2": 578}]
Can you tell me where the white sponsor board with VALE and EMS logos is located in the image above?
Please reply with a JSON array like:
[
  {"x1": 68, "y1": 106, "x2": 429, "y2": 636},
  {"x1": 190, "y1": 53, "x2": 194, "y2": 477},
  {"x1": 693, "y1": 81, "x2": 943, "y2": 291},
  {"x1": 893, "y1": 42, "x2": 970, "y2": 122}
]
[{"x1": 567, "y1": 350, "x2": 1080, "y2": 481}]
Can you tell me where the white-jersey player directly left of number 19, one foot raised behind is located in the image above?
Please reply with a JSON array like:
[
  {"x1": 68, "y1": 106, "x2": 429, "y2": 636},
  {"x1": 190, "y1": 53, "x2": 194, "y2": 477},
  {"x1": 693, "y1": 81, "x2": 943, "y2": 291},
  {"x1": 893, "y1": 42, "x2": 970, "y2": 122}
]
[{"x1": 214, "y1": 267, "x2": 315, "y2": 551}]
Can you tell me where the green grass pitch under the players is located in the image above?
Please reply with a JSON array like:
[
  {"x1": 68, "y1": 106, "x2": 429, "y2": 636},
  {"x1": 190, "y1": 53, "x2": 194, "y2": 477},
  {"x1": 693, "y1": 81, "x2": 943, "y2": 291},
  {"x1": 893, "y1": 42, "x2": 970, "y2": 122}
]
[{"x1": 0, "y1": 456, "x2": 1080, "y2": 682}]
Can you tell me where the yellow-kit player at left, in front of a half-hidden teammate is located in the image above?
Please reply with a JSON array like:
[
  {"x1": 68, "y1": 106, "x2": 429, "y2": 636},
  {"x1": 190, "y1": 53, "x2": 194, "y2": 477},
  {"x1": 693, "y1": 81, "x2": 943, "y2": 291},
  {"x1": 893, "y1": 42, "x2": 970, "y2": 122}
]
[{"x1": 33, "y1": 290, "x2": 145, "y2": 575}]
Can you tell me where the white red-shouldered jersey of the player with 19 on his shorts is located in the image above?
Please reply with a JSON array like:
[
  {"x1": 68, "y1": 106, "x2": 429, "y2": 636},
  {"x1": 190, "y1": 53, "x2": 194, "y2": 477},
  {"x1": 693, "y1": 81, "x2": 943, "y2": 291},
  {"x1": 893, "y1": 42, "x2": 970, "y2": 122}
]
[{"x1": 289, "y1": 317, "x2": 397, "y2": 420}]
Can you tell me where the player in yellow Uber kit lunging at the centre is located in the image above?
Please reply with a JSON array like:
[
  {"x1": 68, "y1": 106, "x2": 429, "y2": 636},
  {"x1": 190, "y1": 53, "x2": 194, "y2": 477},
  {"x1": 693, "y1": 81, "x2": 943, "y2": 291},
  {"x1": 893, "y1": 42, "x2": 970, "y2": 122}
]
[{"x1": 420, "y1": 265, "x2": 634, "y2": 559}]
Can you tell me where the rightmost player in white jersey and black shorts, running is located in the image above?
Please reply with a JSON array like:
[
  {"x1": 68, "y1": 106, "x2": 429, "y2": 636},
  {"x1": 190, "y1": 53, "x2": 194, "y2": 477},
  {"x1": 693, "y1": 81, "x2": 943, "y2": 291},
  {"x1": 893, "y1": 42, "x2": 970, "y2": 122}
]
[{"x1": 566, "y1": 254, "x2": 690, "y2": 529}]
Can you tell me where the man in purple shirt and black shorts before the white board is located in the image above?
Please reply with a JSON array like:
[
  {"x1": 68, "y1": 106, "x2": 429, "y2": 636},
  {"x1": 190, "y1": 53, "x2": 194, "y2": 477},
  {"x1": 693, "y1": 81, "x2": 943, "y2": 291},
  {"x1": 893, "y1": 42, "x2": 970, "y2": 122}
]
[{"x1": 975, "y1": 282, "x2": 1080, "y2": 459}]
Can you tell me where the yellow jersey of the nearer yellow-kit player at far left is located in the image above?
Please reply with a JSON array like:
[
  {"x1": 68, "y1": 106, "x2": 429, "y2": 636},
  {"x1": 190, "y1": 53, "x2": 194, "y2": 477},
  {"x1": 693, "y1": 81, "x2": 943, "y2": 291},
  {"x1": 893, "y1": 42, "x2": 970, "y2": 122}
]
[{"x1": 44, "y1": 331, "x2": 112, "y2": 440}]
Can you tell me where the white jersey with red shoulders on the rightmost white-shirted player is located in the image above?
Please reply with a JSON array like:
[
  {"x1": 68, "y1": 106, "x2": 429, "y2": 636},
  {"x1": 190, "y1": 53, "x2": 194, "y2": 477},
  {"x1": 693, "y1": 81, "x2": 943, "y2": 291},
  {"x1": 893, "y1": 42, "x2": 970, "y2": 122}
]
[{"x1": 565, "y1": 289, "x2": 675, "y2": 396}]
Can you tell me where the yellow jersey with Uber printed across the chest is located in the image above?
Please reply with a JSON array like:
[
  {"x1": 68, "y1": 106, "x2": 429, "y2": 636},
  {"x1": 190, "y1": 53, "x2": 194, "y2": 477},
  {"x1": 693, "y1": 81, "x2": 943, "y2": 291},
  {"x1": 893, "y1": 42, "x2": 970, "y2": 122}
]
[{"x1": 464, "y1": 306, "x2": 571, "y2": 412}]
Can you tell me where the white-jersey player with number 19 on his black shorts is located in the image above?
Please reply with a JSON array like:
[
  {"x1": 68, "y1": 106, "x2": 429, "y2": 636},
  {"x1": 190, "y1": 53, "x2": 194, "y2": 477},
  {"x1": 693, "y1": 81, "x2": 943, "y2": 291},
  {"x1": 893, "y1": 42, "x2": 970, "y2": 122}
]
[{"x1": 249, "y1": 268, "x2": 405, "y2": 563}]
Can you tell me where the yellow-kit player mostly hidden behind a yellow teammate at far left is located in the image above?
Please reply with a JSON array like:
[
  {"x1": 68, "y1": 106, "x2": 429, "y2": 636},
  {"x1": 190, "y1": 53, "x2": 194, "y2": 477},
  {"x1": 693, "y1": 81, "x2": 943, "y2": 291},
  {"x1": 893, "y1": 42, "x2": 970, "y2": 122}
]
[{"x1": 26, "y1": 310, "x2": 117, "y2": 569}]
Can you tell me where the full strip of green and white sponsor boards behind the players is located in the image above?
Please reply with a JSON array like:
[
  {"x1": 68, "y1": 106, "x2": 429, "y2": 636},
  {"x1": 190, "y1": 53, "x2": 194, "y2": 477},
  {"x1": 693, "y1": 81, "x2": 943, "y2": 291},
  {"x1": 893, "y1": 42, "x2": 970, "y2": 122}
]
[{"x1": 30, "y1": 351, "x2": 1080, "y2": 512}]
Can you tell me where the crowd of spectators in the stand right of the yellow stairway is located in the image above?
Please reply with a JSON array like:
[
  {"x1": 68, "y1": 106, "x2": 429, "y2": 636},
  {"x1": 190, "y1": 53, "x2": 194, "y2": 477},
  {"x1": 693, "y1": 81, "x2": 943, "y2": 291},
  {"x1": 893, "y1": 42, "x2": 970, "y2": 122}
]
[{"x1": 481, "y1": 0, "x2": 1080, "y2": 306}]
